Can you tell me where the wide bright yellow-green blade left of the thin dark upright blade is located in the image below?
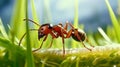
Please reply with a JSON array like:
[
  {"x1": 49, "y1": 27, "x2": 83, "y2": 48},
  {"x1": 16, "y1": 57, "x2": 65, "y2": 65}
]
[{"x1": 10, "y1": 0, "x2": 26, "y2": 42}]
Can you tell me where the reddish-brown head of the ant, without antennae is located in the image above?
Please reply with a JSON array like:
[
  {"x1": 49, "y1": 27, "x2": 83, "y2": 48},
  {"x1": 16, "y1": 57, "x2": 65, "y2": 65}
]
[{"x1": 38, "y1": 23, "x2": 53, "y2": 40}]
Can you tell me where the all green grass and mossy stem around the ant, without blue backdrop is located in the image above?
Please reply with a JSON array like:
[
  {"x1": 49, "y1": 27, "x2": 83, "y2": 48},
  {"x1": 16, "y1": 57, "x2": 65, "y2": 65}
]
[{"x1": 0, "y1": 0, "x2": 120, "y2": 67}]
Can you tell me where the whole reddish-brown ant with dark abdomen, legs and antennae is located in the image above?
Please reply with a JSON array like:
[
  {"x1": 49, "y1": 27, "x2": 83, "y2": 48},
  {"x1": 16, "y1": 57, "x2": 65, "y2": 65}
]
[{"x1": 19, "y1": 19, "x2": 94, "y2": 55}]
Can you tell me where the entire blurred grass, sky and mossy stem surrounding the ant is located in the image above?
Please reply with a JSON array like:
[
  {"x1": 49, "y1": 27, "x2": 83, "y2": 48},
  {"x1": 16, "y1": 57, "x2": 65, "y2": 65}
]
[{"x1": 0, "y1": 0, "x2": 120, "y2": 67}]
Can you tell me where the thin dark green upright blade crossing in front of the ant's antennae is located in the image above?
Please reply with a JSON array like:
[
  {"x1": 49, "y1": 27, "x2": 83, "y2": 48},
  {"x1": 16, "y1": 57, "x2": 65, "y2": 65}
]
[{"x1": 25, "y1": 0, "x2": 35, "y2": 67}]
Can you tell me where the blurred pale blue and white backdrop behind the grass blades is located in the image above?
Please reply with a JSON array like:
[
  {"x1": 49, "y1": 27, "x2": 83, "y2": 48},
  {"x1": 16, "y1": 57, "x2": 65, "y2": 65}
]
[{"x1": 0, "y1": 0, "x2": 119, "y2": 32}]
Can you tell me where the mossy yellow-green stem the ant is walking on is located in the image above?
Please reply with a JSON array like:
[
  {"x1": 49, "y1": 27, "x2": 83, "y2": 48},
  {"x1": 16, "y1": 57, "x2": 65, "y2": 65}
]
[{"x1": 33, "y1": 44, "x2": 120, "y2": 67}]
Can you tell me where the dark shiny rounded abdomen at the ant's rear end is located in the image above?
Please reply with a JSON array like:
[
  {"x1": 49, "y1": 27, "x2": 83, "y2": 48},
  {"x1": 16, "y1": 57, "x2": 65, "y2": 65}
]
[{"x1": 72, "y1": 29, "x2": 86, "y2": 42}]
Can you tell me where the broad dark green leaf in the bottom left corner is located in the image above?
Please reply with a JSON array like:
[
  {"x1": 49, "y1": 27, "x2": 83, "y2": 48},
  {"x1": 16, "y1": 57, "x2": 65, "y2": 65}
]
[{"x1": 0, "y1": 37, "x2": 26, "y2": 67}]
